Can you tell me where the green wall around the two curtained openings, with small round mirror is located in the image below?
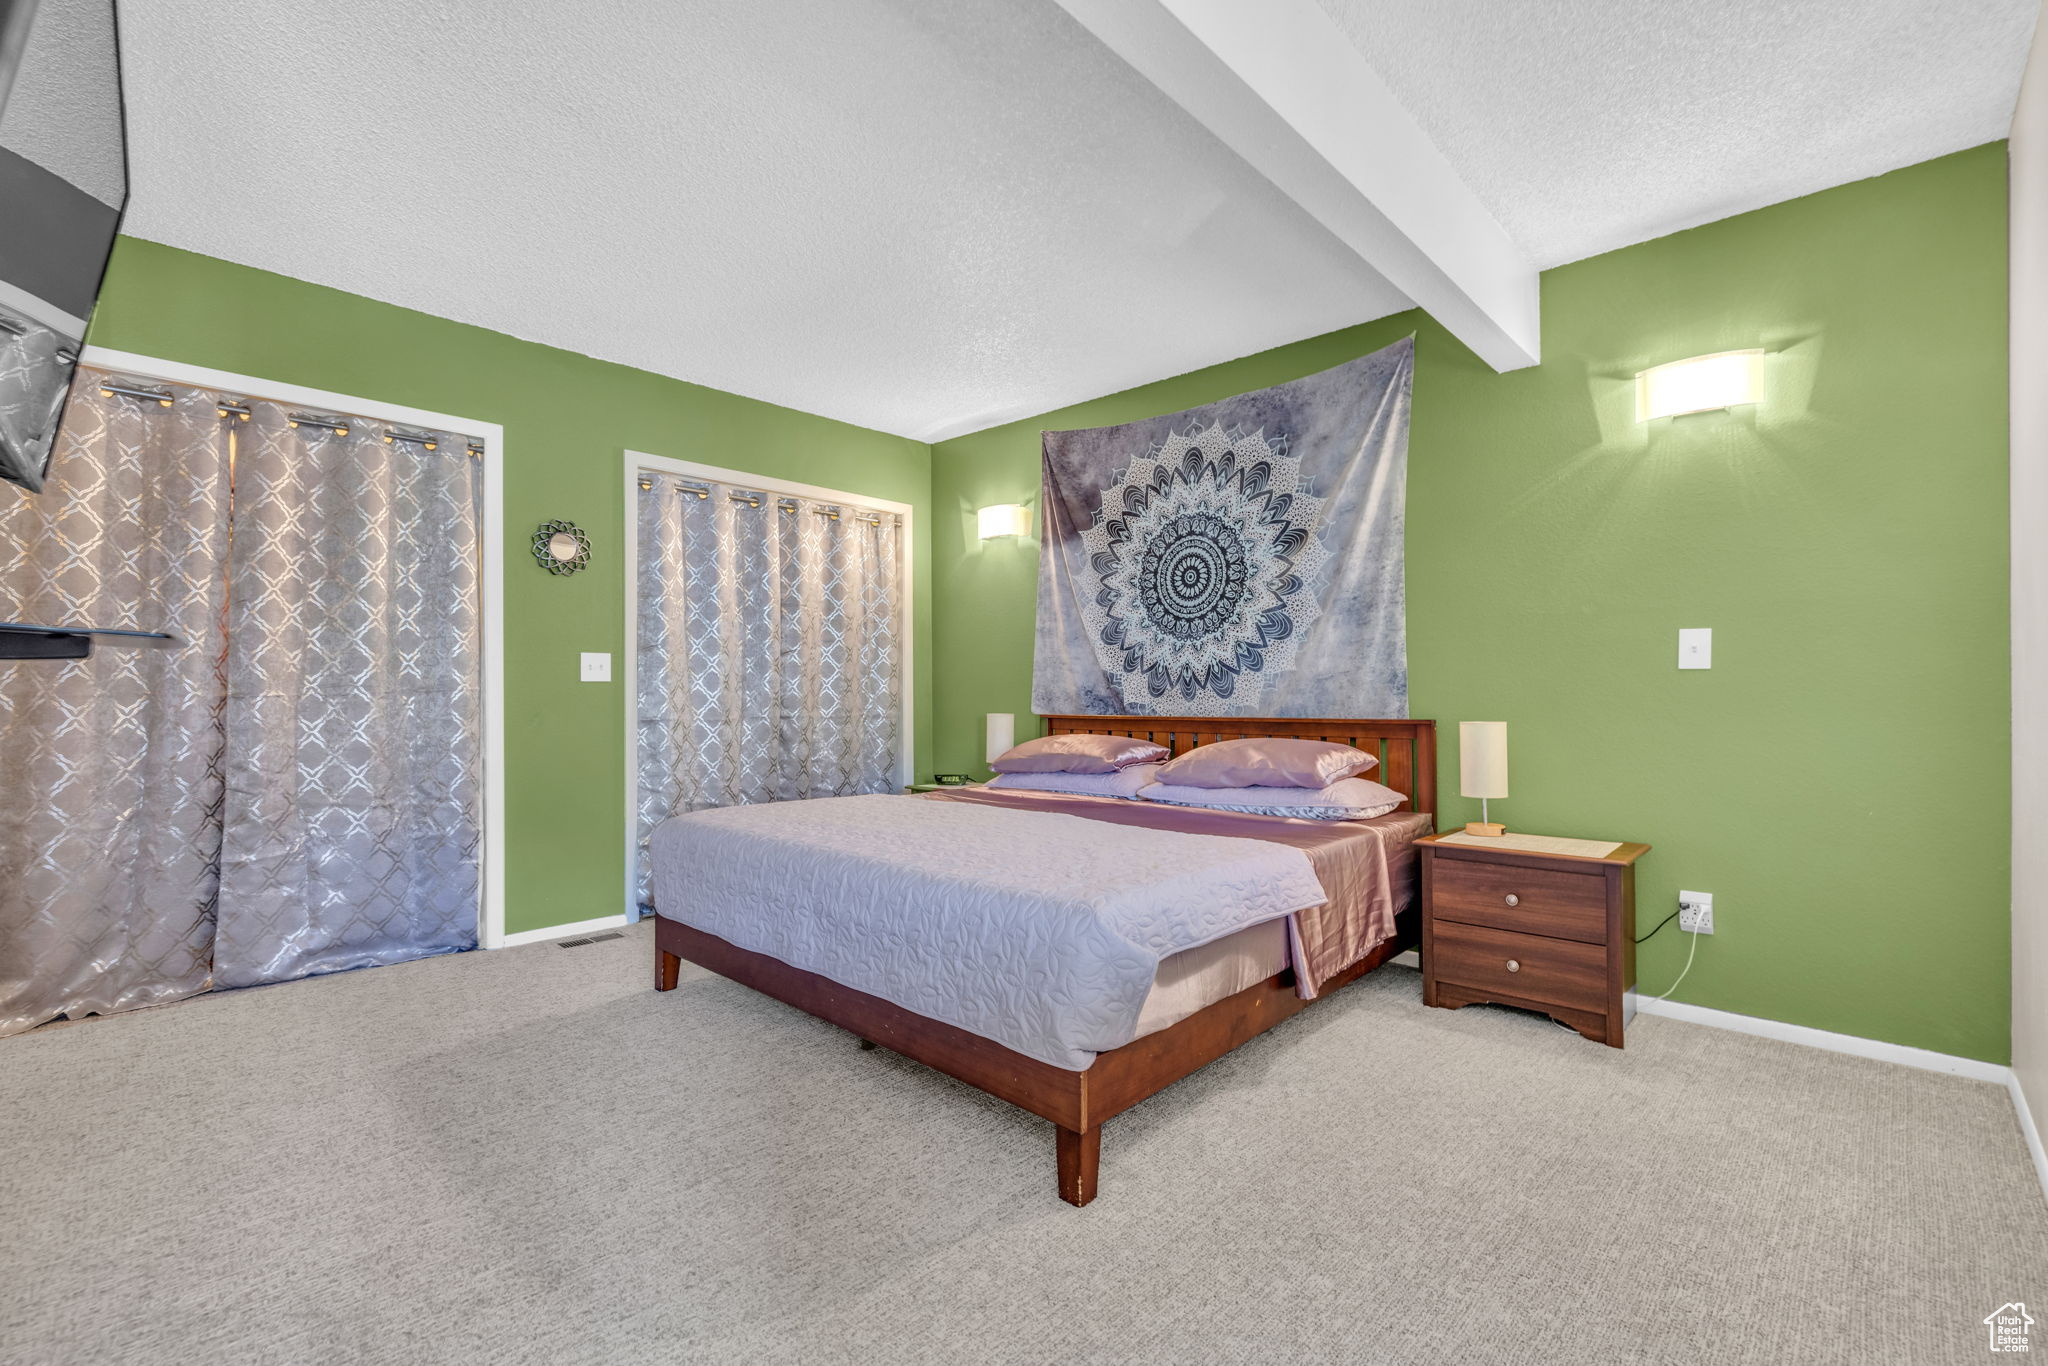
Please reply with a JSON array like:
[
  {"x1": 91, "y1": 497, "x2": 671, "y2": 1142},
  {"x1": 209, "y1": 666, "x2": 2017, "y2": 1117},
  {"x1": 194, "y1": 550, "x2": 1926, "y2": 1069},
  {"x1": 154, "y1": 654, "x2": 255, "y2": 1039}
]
[{"x1": 90, "y1": 238, "x2": 932, "y2": 934}]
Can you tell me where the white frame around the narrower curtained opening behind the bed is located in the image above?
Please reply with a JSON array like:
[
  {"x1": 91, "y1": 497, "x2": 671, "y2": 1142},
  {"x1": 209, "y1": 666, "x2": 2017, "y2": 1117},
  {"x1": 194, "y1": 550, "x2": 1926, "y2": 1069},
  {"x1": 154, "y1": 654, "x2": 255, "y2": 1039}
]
[{"x1": 625, "y1": 451, "x2": 918, "y2": 917}]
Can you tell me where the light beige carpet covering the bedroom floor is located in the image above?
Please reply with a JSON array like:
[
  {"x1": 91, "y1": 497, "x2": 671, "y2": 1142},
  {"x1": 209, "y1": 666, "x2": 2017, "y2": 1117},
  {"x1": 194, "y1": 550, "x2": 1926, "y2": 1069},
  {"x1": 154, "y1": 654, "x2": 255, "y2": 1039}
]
[{"x1": 0, "y1": 928, "x2": 2048, "y2": 1364}]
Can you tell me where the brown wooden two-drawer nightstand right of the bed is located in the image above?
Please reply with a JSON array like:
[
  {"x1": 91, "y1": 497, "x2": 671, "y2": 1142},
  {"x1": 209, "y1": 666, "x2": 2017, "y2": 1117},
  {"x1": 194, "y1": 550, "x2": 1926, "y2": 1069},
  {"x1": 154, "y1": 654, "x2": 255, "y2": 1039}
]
[{"x1": 1415, "y1": 831, "x2": 1651, "y2": 1049}]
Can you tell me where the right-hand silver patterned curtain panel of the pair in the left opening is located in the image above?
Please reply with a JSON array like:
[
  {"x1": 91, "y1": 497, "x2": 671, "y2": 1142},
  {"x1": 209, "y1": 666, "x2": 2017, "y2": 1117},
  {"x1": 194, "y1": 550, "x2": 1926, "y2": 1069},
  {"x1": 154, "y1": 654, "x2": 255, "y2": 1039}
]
[{"x1": 213, "y1": 401, "x2": 483, "y2": 987}]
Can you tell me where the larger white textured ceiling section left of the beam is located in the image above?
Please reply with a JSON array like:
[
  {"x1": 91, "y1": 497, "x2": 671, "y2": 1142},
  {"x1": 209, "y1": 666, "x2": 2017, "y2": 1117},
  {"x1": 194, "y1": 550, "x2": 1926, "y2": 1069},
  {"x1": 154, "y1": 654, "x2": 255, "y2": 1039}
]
[{"x1": 123, "y1": 0, "x2": 1405, "y2": 438}]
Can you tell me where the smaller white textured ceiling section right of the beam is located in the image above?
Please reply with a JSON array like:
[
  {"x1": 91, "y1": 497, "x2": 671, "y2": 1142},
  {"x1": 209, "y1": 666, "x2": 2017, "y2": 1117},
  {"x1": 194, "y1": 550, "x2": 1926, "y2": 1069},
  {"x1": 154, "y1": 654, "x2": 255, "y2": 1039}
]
[{"x1": 1317, "y1": 0, "x2": 2036, "y2": 268}]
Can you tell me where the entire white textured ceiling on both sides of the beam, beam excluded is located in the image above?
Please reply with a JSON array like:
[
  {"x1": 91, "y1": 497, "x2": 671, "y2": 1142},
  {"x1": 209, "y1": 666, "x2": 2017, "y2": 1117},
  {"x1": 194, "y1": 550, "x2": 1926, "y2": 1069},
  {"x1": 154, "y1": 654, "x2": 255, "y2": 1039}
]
[{"x1": 121, "y1": 0, "x2": 2032, "y2": 440}]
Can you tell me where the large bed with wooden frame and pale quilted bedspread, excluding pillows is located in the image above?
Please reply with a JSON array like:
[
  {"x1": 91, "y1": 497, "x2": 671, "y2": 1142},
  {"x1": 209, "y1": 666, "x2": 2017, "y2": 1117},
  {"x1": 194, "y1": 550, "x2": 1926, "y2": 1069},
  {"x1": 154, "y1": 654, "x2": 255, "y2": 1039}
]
[{"x1": 653, "y1": 717, "x2": 1436, "y2": 1204}]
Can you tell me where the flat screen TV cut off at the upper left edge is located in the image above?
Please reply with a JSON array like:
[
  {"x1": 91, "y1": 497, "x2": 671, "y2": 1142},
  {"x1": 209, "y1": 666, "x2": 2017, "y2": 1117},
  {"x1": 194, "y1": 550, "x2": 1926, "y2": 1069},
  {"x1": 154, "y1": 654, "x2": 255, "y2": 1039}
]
[{"x1": 0, "y1": 0, "x2": 127, "y2": 494}]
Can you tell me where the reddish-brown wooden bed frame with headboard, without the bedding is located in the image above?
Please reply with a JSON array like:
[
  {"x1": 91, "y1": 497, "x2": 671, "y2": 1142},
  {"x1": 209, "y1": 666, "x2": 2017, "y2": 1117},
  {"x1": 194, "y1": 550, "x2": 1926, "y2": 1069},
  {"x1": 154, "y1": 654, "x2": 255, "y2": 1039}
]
[{"x1": 653, "y1": 717, "x2": 1436, "y2": 1204}]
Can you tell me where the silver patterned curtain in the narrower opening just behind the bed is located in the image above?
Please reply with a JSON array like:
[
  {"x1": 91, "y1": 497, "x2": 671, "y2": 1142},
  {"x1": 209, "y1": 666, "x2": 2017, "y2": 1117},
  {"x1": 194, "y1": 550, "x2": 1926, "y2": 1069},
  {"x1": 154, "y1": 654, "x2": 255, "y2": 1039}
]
[{"x1": 635, "y1": 473, "x2": 903, "y2": 907}]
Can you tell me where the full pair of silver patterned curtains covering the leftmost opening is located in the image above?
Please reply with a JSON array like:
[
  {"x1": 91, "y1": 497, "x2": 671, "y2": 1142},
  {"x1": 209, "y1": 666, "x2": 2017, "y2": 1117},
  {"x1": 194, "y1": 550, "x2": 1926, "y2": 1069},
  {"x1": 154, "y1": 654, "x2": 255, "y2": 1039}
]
[{"x1": 0, "y1": 371, "x2": 481, "y2": 1034}]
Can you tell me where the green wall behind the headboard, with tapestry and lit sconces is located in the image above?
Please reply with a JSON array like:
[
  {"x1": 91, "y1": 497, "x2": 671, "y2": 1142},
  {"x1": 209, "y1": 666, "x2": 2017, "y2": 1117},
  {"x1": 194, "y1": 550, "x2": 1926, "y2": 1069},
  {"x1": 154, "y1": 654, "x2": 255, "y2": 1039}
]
[{"x1": 932, "y1": 143, "x2": 2009, "y2": 1063}]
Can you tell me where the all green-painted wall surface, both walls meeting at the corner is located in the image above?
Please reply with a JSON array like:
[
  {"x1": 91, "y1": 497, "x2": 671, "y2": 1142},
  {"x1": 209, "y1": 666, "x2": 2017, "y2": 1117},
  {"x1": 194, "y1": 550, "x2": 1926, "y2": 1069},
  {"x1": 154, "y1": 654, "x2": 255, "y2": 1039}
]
[{"x1": 92, "y1": 143, "x2": 2009, "y2": 1061}]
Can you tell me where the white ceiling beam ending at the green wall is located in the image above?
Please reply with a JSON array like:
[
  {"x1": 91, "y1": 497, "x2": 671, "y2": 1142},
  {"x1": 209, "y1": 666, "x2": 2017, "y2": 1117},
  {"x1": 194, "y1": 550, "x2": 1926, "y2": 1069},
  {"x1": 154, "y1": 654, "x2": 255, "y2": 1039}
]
[{"x1": 1059, "y1": 0, "x2": 1540, "y2": 371}]
